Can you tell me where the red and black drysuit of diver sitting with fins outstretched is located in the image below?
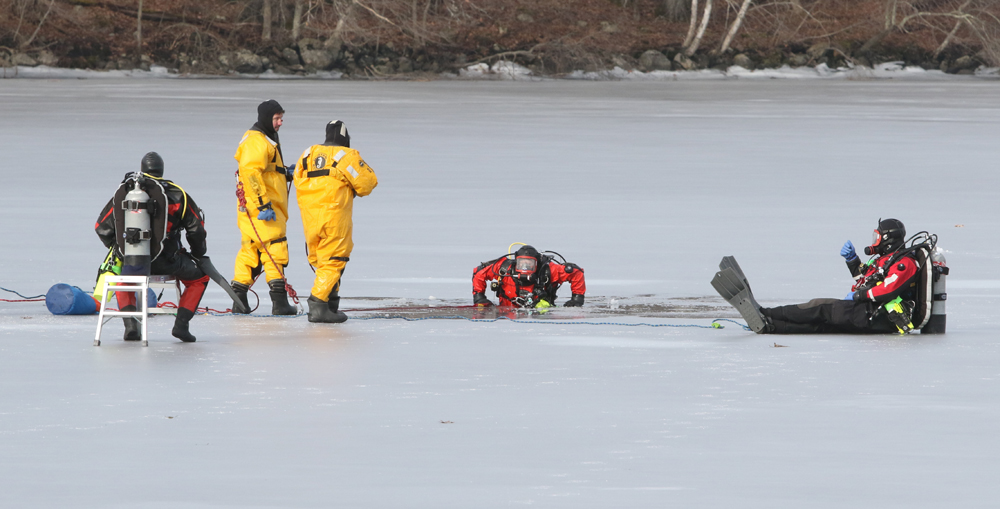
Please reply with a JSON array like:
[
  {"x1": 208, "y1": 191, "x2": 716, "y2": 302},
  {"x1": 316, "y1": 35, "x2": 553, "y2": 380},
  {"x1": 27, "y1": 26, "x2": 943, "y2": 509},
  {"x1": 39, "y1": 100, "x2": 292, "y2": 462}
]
[{"x1": 760, "y1": 253, "x2": 918, "y2": 334}]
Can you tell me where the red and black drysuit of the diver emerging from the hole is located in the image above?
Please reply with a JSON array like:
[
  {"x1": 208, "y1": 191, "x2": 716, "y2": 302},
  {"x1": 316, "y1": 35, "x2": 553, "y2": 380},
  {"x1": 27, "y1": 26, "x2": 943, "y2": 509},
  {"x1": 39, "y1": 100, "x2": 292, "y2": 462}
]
[{"x1": 472, "y1": 256, "x2": 587, "y2": 308}]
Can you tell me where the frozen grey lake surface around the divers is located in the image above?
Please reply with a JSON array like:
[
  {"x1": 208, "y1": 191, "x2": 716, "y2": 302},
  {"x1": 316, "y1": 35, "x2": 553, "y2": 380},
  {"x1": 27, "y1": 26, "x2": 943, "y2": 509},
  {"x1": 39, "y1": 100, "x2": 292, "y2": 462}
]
[{"x1": 0, "y1": 78, "x2": 1000, "y2": 509}]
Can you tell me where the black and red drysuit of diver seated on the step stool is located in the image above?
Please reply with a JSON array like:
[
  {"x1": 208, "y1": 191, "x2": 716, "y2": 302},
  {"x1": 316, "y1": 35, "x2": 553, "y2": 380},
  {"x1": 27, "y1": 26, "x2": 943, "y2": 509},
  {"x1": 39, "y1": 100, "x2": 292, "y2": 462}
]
[{"x1": 94, "y1": 174, "x2": 209, "y2": 313}]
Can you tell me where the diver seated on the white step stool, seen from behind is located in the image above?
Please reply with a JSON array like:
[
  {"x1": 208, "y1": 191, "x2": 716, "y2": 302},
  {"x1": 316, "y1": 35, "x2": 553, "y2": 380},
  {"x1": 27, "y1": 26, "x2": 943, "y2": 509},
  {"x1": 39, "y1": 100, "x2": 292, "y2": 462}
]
[{"x1": 94, "y1": 152, "x2": 209, "y2": 342}]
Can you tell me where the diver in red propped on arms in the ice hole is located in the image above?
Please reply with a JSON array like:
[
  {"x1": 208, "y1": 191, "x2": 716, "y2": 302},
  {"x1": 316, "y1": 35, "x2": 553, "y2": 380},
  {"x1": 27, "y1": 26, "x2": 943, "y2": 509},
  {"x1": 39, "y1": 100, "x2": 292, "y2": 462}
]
[{"x1": 472, "y1": 245, "x2": 587, "y2": 310}]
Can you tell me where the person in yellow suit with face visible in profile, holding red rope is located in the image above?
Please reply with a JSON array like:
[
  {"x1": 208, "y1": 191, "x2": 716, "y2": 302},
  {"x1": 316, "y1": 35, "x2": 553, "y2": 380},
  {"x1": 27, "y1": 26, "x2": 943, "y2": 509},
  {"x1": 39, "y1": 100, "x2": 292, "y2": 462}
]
[{"x1": 232, "y1": 99, "x2": 296, "y2": 315}]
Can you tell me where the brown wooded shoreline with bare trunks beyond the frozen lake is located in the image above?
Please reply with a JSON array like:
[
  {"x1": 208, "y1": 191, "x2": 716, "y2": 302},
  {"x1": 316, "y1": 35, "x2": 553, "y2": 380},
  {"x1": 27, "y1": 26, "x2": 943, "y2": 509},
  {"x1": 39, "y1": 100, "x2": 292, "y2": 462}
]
[{"x1": 0, "y1": 0, "x2": 1000, "y2": 70}]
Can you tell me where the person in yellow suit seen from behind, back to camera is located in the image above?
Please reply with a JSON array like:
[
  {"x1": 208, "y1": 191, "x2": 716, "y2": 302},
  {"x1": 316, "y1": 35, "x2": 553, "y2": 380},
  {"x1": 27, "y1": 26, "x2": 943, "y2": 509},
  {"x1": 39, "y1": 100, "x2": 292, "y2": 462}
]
[{"x1": 293, "y1": 120, "x2": 378, "y2": 323}]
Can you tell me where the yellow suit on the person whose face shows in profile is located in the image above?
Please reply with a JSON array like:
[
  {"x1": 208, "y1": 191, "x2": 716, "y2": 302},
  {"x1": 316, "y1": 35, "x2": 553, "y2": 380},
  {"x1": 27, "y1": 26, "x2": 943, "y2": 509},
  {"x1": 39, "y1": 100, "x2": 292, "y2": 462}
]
[{"x1": 233, "y1": 129, "x2": 288, "y2": 286}]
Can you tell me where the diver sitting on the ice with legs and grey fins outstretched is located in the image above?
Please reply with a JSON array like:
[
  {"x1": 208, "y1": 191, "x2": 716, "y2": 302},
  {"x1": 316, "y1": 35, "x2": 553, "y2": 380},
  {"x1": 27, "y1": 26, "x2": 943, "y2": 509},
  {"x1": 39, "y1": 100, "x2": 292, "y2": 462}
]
[{"x1": 712, "y1": 219, "x2": 933, "y2": 334}]
